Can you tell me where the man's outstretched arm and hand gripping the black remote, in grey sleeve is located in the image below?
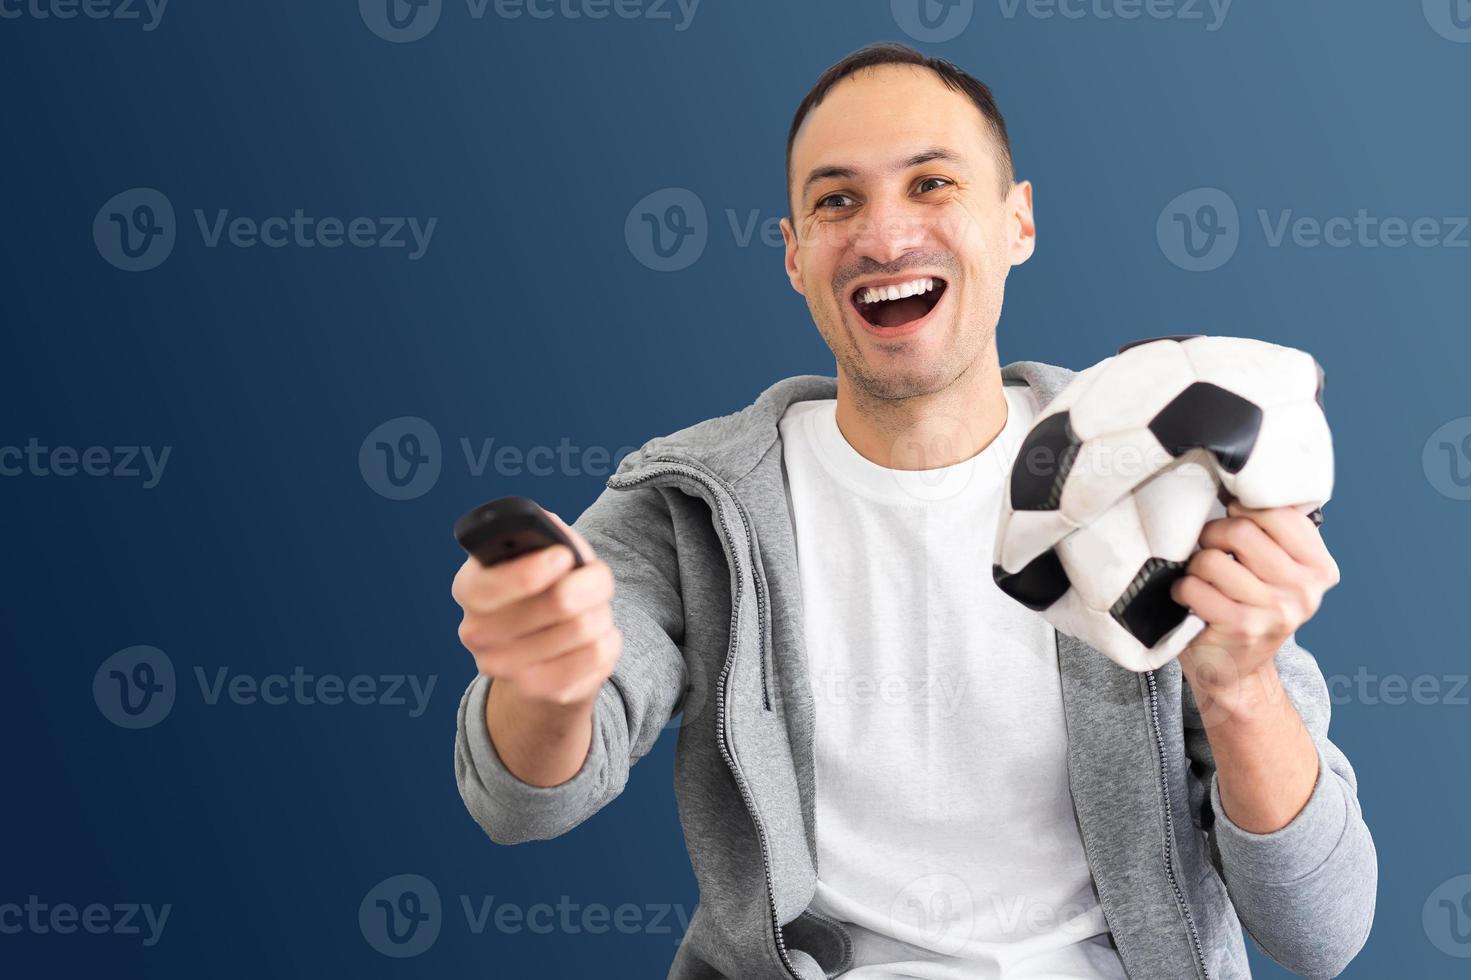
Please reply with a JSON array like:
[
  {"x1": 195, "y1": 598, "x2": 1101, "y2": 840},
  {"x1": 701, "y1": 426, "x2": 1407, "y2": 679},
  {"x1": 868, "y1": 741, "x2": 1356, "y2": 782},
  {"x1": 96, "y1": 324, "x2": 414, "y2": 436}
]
[{"x1": 455, "y1": 476, "x2": 685, "y2": 843}]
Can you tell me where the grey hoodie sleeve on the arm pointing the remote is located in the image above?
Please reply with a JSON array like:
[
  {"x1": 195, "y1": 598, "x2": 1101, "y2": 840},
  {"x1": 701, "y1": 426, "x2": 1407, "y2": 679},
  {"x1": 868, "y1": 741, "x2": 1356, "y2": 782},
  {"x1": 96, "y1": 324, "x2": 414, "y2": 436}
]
[{"x1": 455, "y1": 473, "x2": 685, "y2": 843}]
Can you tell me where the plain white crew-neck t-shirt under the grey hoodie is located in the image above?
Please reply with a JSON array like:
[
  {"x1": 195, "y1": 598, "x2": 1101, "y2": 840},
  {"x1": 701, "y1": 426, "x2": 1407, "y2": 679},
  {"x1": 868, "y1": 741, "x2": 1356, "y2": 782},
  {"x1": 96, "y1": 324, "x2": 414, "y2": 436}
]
[{"x1": 780, "y1": 386, "x2": 1124, "y2": 980}]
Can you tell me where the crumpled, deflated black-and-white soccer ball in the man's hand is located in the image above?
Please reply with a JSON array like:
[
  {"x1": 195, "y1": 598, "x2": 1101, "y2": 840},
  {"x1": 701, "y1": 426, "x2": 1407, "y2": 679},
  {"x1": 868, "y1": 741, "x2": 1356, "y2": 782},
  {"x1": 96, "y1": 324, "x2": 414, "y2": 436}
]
[{"x1": 991, "y1": 334, "x2": 1333, "y2": 671}]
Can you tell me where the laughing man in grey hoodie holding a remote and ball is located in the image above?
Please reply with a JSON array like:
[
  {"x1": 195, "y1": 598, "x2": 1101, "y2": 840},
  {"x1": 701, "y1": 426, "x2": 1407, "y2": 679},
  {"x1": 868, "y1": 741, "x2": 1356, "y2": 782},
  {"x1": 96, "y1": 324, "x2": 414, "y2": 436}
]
[{"x1": 453, "y1": 46, "x2": 1377, "y2": 980}]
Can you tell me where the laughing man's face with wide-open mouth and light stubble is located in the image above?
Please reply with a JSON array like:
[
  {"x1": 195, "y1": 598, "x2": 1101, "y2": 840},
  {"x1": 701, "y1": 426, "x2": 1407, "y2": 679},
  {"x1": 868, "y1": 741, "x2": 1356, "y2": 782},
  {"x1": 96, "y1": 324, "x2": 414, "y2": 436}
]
[{"x1": 781, "y1": 65, "x2": 1034, "y2": 399}]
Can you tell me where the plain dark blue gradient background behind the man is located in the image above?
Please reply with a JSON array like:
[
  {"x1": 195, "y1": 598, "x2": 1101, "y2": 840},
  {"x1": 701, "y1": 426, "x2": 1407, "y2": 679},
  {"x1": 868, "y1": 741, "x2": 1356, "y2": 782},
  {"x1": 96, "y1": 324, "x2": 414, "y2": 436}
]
[{"x1": 0, "y1": 0, "x2": 1471, "y2": 977}]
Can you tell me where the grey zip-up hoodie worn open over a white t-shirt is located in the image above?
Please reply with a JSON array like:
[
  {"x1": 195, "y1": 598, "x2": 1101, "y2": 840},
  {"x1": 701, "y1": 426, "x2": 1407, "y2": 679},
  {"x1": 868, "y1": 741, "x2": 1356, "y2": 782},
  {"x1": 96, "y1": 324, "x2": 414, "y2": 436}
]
[{"x1": 455, "y1": 361, "x2": 1378, "y2": 980}]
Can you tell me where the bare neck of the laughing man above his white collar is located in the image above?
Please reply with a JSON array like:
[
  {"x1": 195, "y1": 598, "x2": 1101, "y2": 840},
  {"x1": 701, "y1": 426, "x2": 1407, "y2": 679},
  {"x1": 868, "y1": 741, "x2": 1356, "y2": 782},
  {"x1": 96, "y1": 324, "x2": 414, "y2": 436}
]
[{"x1": 837, "y1": 344, "x2": 1008, "y2": 469}]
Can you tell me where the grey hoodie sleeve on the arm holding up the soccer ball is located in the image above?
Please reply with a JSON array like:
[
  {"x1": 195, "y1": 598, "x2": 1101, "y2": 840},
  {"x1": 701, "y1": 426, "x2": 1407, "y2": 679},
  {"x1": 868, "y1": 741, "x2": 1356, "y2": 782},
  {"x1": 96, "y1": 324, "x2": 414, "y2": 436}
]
[{"x1": 1184, "y1": 634, "x2": 1378, "y2": 977}]
